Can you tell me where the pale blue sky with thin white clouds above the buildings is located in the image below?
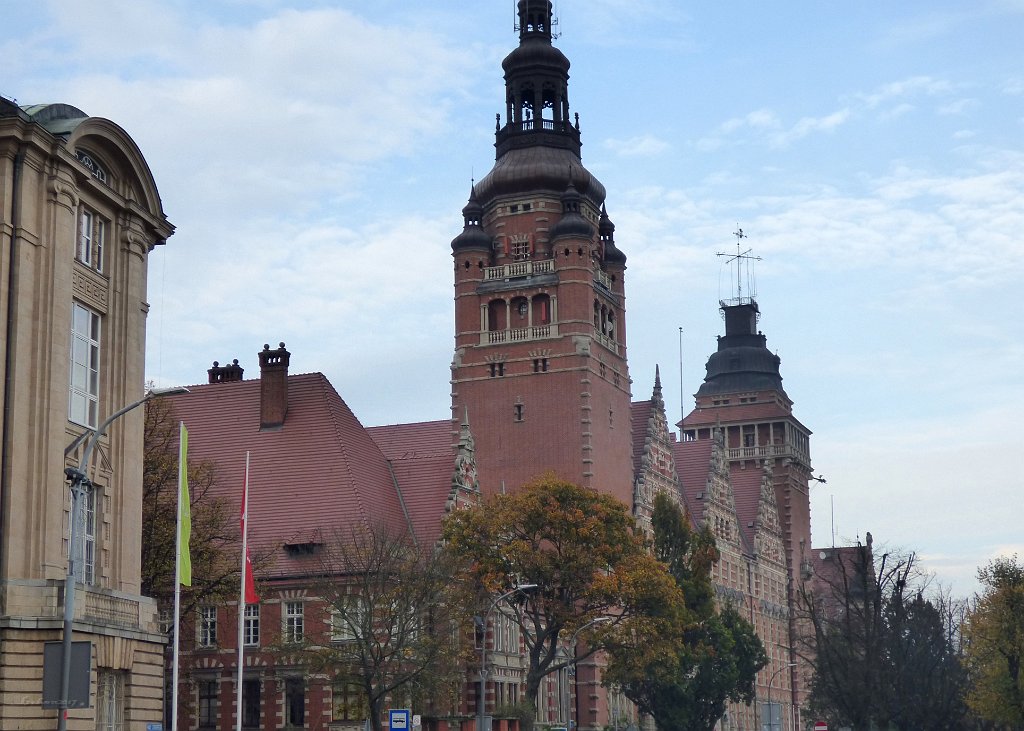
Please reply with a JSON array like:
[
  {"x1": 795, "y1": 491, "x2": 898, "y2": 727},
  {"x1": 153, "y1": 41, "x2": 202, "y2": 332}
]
[{"x1": 0, "y1": 0, "x2": 1024, "y2": 597}]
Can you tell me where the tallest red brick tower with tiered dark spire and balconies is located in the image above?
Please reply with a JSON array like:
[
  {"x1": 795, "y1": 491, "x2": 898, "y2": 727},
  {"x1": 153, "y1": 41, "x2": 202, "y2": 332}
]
[{"x1": 452, "y1": 0, "x2": 633, "y2": 504}]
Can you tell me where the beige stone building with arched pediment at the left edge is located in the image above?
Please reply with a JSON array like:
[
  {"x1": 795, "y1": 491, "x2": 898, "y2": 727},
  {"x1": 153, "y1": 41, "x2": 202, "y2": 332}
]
[{"x1": 0, "y1": 99, "x2": 174, "y2": 729}]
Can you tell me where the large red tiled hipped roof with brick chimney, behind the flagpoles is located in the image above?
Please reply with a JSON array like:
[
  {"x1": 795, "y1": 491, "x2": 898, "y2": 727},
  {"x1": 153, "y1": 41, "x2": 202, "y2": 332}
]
[{"x1": 167, "y1": 373, "x2": 409, "y2": 576}]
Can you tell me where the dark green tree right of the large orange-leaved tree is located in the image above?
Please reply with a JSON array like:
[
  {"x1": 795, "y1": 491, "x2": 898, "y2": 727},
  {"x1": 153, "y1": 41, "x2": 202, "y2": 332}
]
[{"x1": 605, "y1": 493, "x2": 768, "y2": 730}]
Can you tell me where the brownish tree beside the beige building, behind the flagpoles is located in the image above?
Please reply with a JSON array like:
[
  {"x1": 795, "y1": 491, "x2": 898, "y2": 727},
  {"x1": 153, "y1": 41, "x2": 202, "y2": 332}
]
[{"x1": 141, "y1": 398, "x2": 258, "y2": 616}]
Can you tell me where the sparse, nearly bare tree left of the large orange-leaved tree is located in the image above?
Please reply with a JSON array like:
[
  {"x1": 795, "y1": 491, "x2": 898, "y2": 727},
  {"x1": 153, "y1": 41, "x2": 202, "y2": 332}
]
[{"x1": 299, "y1": 525, "x2": 469, "y2": 731}]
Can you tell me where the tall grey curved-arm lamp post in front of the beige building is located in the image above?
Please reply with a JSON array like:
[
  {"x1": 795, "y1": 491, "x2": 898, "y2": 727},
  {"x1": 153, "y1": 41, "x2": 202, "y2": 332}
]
[{"x1": 57, "y1": 386, "x2": 188, "y2": 731}]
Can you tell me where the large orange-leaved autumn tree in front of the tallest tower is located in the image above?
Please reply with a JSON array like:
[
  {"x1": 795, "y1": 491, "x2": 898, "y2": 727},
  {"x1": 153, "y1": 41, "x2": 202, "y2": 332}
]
[{"x1": 443, "y1": 476, "x2": 683, "y2": 710}]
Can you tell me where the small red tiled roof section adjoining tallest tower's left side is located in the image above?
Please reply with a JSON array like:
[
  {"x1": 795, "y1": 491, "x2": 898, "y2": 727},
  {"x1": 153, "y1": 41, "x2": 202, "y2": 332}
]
[{"x1": 367, "y1": 420, "x2": 456, "y2": 546}]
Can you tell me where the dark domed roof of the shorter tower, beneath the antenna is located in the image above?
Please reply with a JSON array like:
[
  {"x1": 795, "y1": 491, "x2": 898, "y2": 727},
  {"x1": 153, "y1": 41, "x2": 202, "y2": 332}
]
[{"x1": 697, "y1": 300, "x2": 788, "y2": 398}]
